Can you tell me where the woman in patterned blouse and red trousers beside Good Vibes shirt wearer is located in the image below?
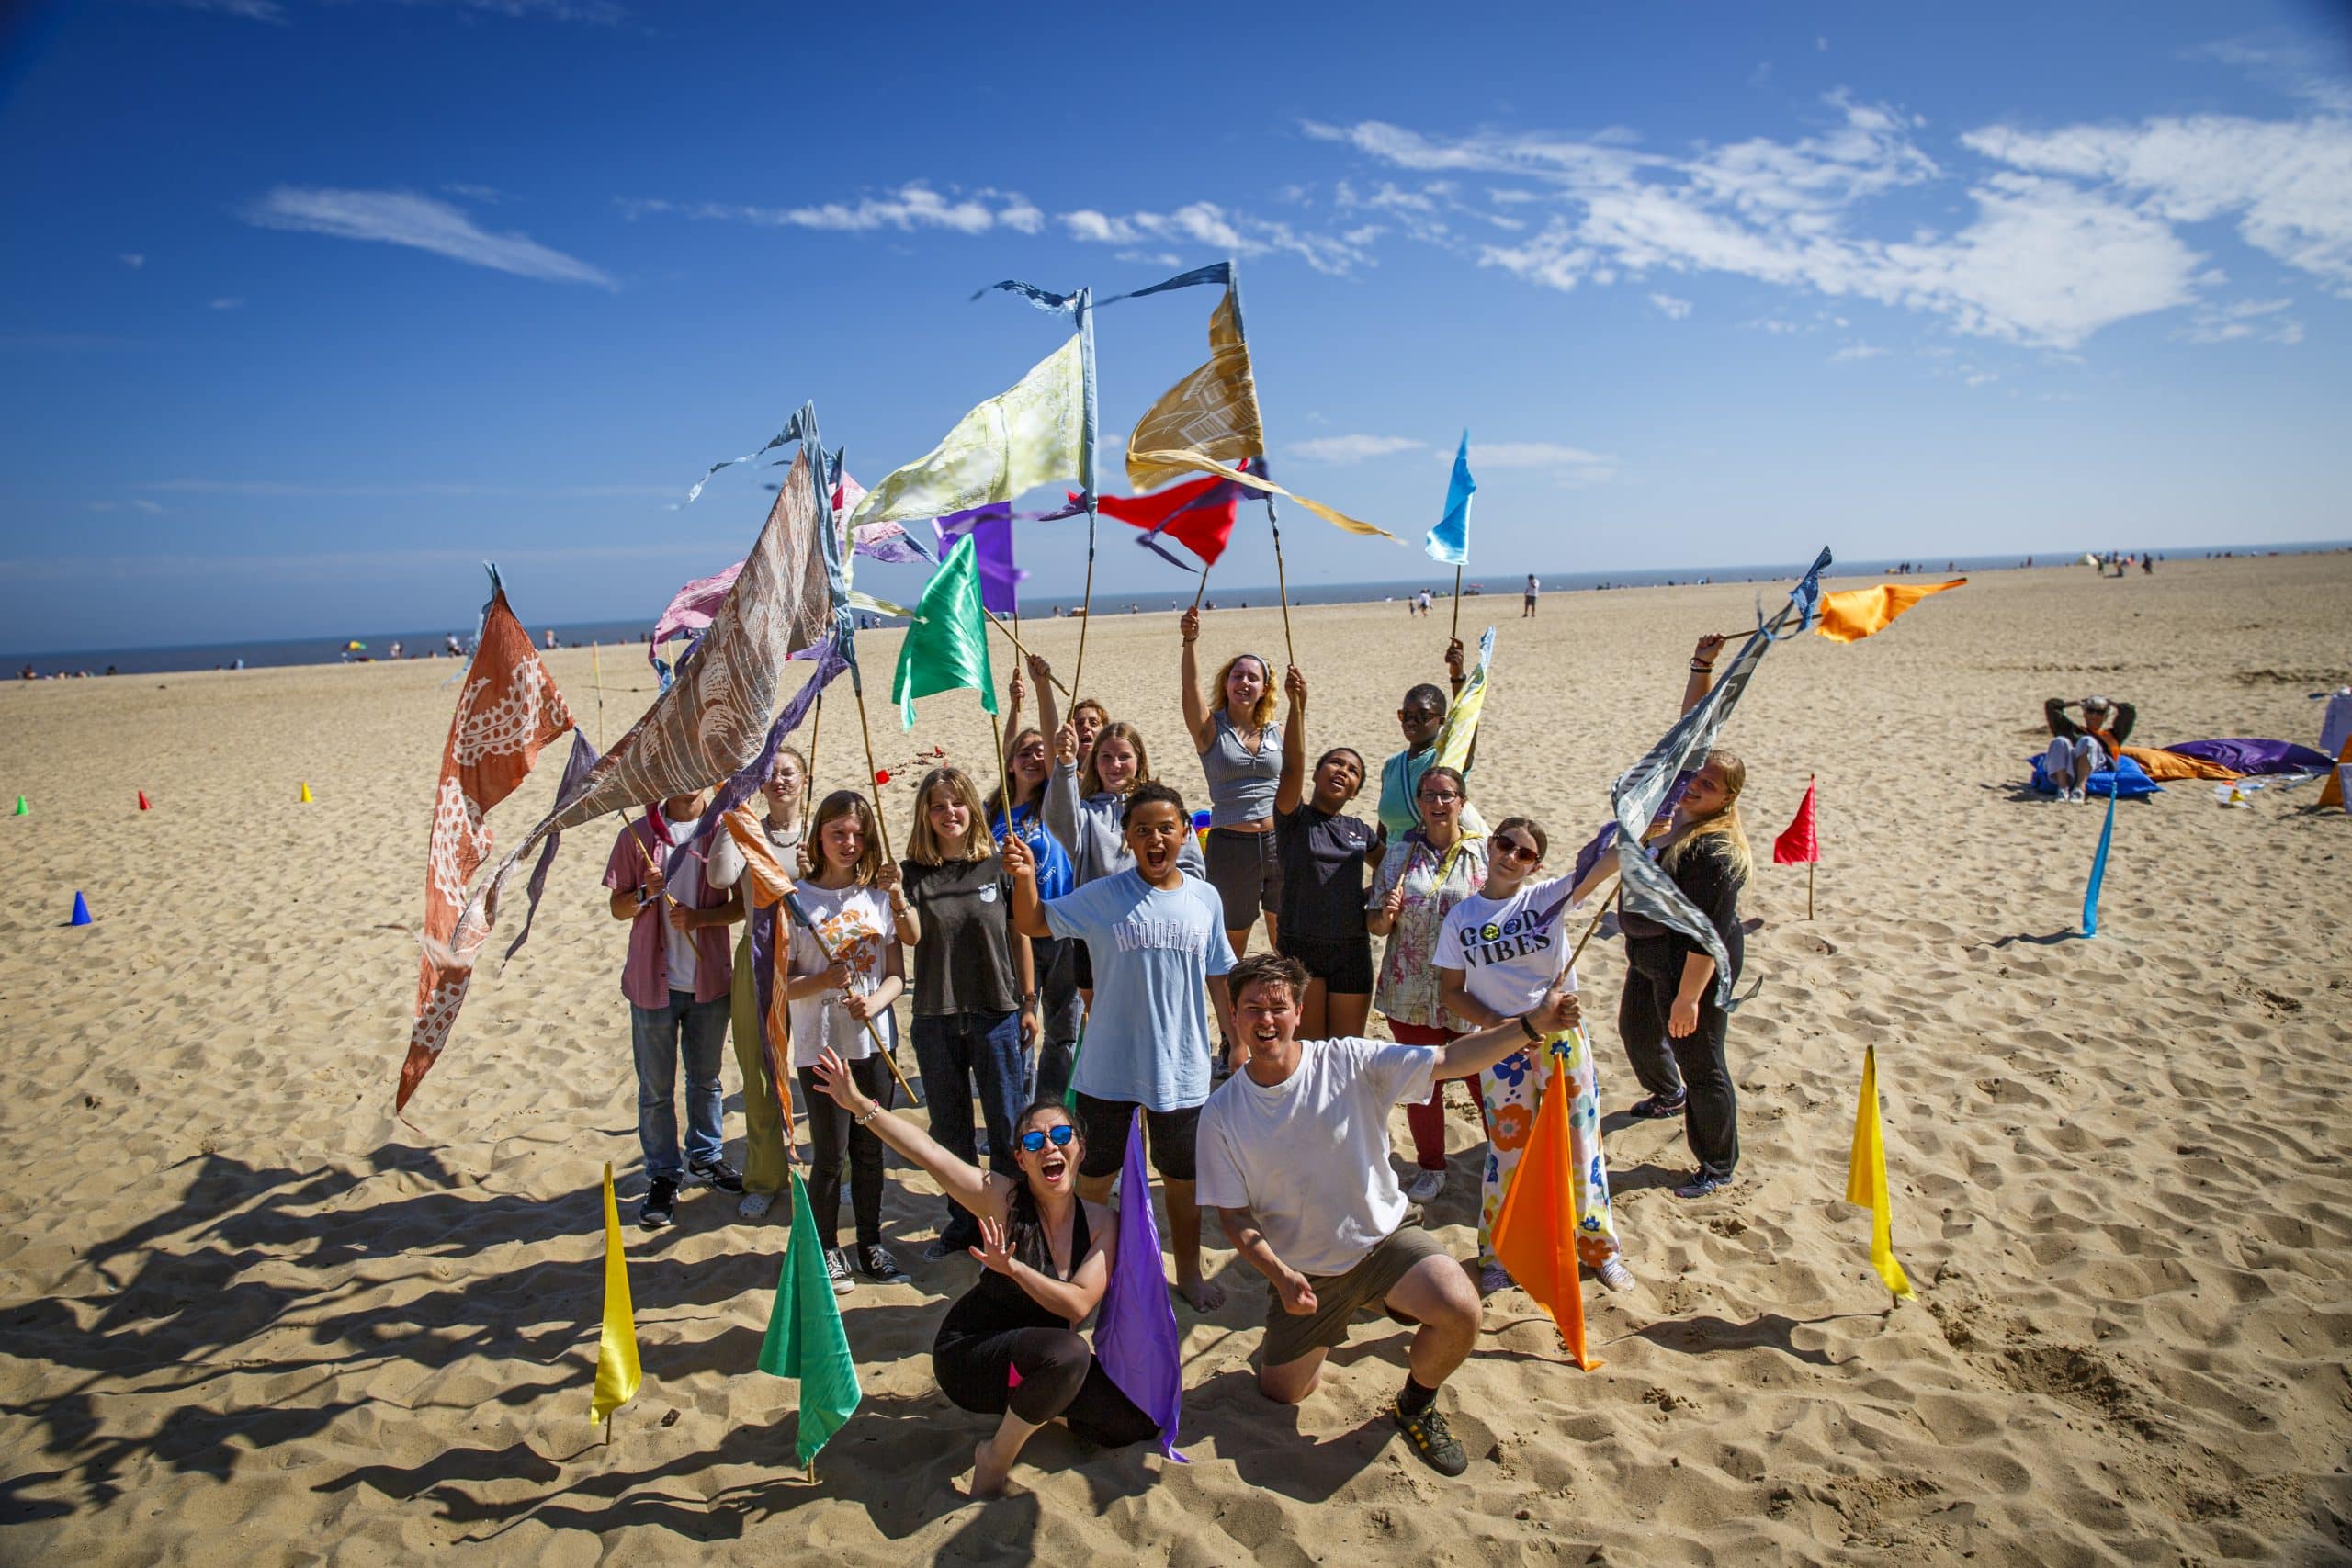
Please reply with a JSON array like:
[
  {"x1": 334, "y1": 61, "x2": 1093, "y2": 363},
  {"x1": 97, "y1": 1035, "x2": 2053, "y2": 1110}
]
[{"x1": 1364, "y1": 766, "x2": 1487, "y2": 1203}]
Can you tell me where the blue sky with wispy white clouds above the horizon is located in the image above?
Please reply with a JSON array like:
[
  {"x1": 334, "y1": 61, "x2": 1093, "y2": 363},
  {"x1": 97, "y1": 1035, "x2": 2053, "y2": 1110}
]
[{"x1": 0, "y1": 0, "x2": 2352, "y2": 649}]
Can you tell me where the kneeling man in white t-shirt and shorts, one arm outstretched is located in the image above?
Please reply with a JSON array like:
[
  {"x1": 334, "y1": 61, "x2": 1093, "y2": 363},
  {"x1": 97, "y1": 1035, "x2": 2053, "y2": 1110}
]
[{"x1": 1194, "y1": 952, "x2": 1580, "y2": 1476}]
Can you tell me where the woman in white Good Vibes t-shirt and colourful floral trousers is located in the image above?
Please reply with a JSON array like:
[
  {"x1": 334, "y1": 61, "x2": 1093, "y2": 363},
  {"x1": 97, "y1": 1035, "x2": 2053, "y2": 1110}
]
[{"x1": 1437, "y1": 816, "x2": 1633, "y2": 1295}]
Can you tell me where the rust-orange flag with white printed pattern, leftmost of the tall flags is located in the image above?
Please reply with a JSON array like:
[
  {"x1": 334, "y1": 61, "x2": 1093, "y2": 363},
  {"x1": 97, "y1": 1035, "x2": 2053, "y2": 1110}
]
[{"x1": 393, "y1": 573, "x2": 571, "y2": 1110}]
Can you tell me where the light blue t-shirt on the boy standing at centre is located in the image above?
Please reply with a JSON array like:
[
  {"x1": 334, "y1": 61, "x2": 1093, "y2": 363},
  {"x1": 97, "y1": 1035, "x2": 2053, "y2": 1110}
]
[{"x1": 1045, "y1": 867, "x2": 1232, "y2": 1110}]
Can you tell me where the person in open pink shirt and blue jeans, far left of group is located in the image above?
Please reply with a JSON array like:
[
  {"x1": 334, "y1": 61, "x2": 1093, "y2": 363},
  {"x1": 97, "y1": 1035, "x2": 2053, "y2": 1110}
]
[{"x1": 605, "y1": 790, "x2": 743, "y2": 1229}]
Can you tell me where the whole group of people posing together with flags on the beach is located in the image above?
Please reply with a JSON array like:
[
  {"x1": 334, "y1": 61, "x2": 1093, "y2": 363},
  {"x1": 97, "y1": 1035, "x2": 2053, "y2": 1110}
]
[{"x1": 605, "y1": 611, "x2": 1747, "y2": 1493}]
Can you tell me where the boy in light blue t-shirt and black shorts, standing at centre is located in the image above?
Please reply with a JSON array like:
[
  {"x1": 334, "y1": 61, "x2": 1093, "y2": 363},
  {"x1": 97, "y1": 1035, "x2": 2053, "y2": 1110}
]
[{"x1": 1004, "y1": 783, "x2": 1232, "y2": 1312}]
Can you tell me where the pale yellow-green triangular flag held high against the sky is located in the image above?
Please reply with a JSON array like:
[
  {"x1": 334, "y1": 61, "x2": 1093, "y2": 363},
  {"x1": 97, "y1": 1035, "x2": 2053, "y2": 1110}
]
[{"x1": 849, "y1": 333, "x2": 1087, "y2": 536}]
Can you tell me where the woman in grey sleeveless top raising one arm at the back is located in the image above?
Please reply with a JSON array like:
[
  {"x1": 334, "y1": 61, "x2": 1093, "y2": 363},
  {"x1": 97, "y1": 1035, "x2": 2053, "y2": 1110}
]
[{"x1": 1176, "y1": 609, "x2": 1282, "y2": 957}]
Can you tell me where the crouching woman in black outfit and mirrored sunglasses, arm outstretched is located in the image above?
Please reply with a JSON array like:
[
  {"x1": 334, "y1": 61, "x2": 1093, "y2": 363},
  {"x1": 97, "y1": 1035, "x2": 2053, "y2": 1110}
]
[{"x1": 811, "y1": 1051, "x2": 1159, "y2": 1497}]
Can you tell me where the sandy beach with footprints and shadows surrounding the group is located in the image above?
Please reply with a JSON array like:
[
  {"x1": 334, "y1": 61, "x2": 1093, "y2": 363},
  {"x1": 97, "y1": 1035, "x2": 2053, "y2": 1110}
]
[{"x1": 0, "y1": 555, "x2": 2352, "y2": 1568}]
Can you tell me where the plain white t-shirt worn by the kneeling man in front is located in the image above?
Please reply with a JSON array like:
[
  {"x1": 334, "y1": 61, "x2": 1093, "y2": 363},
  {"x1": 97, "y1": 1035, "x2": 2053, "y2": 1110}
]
[{"x1": 1194, "y1": 1039, "x2": 1437, "y2": 1279}]
